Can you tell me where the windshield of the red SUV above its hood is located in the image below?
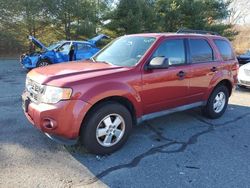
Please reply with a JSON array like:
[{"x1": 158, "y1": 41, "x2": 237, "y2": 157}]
[{"x1": 93, "y1": 36, "x2": 155, "y2": 67}]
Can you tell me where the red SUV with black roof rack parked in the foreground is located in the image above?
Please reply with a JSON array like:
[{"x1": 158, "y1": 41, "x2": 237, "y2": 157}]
[{"x1": 22, "y1": 30, "x2": 238, "y2": 154}]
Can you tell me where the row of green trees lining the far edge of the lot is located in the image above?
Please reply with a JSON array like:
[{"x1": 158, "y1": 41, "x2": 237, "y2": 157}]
[{"x1": 0, "y1": 0, "x2": 237, "y2": 54}]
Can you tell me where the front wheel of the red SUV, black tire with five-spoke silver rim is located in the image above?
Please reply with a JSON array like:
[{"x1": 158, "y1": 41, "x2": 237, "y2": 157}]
[{"x1": 80, "y1": 102, "x2": 132, "y2": 155}]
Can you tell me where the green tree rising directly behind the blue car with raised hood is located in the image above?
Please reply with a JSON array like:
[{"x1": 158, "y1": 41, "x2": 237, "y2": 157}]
[{"x1": 45, "y1": 0, "x2": 110, "y2": 40}]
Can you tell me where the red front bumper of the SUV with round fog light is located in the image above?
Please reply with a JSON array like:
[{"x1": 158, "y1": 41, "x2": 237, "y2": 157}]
[{"x1": 22, "y1": 93, "x2": 91, "y2": 140}]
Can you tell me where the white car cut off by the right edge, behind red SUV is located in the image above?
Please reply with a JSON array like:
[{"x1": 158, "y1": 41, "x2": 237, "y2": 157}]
[{"x1": 238, "y1": 63, "x2": 250, "y2": 87}]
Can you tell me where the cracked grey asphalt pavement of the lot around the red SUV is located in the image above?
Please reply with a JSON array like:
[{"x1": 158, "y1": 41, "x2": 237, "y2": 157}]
[{"x1": 0, "y1": 60, "x2": 250, "y2": 188}]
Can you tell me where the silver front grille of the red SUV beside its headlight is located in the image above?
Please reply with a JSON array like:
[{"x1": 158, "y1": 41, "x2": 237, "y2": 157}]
[{"x1": 26, "y1": 78, "x2": 42, "y2": 103}]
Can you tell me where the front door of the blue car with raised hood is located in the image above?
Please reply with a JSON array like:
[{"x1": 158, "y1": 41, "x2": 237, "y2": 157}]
[{"x1": 55, "y1": 42, "x2": 71, "y2": 63}]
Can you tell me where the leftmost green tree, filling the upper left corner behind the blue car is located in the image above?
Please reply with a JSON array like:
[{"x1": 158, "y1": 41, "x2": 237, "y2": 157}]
[{"x1": 0, "y1": 0, "x2": 47, "y2": 53}]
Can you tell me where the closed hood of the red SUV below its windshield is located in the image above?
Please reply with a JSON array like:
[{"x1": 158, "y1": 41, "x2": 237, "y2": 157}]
[{"x1": 27, "y1": 61, "x2": 128, "y2": 86}]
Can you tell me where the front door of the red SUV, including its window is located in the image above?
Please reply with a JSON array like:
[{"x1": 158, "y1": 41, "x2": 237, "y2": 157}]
[{"x1": 141, "y1": 39, "x2": 190, "y2": 114}]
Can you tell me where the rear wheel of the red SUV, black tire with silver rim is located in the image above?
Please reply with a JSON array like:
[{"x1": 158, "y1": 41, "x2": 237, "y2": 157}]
[{"x1": 202, "y1": 85, "x2": 229, "y2": 119}]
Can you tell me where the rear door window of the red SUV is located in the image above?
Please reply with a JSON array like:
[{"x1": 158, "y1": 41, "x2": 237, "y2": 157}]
[{"x1": 189, "y1": 39, "x2": 214, "y2": 63}]
